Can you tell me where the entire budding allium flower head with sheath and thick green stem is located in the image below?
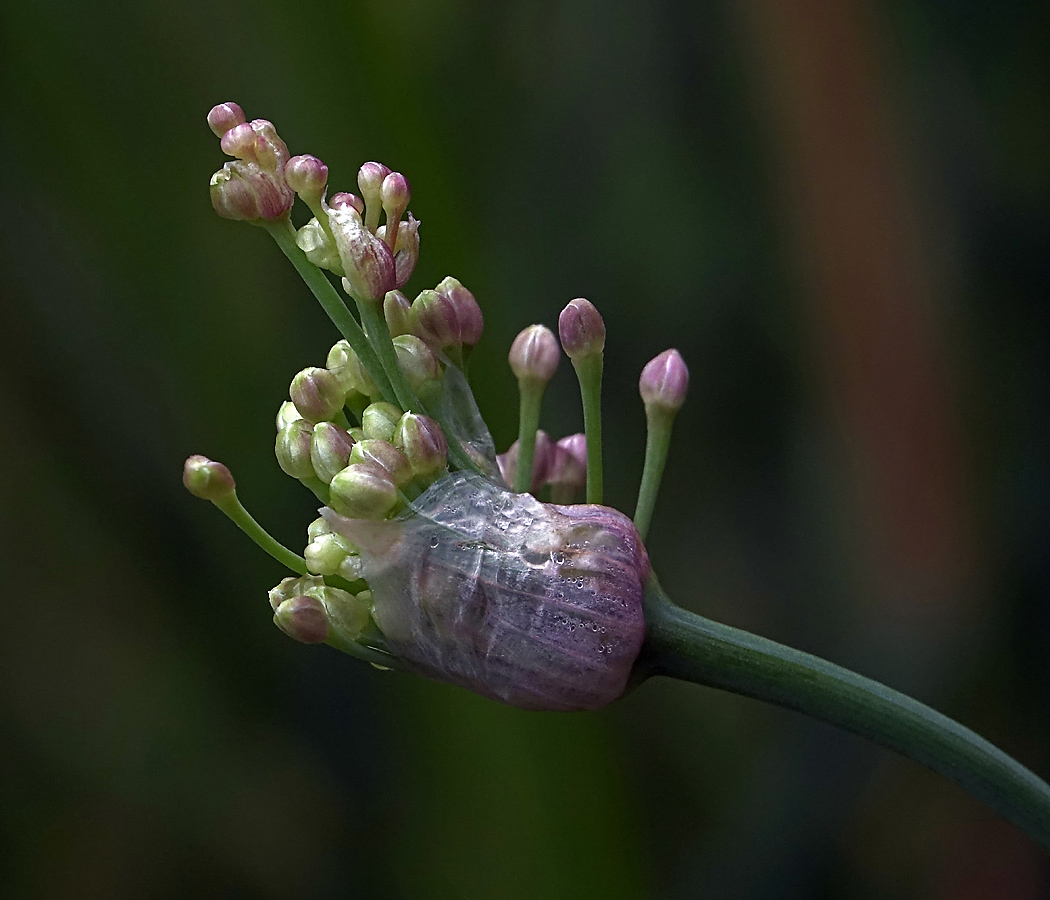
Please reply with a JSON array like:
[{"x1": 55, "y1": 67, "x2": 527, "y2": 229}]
[{"x1": 183, "y1": 103, "x2": 1050, "y2": 846}]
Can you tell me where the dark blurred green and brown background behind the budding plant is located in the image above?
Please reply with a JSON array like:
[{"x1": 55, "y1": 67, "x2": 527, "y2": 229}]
[{"x1": 0, "y1": 0, "x2": 1050, "y2": 900}]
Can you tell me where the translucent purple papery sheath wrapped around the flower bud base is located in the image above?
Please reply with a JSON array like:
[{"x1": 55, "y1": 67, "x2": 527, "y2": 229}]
[{"x1": 324, "y1": 473, "x2": 649, "y2": 712}]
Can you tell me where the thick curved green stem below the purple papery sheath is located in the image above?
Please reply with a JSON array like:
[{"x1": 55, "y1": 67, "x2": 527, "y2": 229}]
[{"x1": 641, "y1": 577, "x2": 1050, "y2": 849}]
